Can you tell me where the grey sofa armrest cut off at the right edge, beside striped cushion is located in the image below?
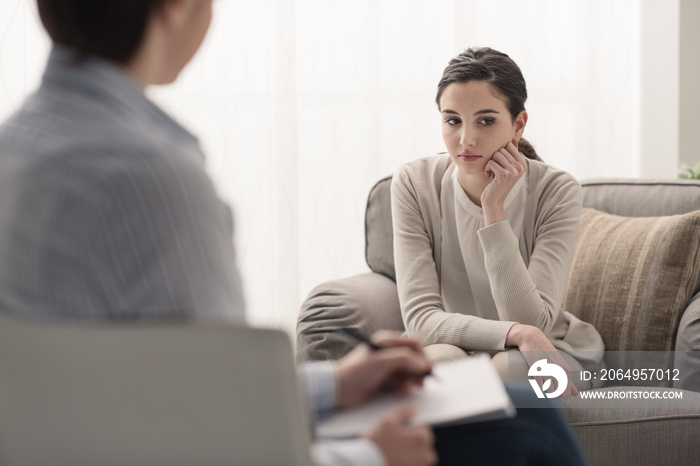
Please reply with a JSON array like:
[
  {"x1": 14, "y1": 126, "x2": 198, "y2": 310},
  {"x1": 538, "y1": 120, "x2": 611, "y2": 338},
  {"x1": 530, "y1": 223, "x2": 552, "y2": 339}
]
[{"x1": 673, "y1": 293, "x2": 700, "y2": 392}]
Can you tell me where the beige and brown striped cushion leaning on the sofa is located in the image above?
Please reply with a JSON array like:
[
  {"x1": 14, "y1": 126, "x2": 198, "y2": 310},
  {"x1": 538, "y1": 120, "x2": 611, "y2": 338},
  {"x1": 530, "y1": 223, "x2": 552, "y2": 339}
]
[{"x1": 564, "y1": 208, "x2": 700, "y2": 351}]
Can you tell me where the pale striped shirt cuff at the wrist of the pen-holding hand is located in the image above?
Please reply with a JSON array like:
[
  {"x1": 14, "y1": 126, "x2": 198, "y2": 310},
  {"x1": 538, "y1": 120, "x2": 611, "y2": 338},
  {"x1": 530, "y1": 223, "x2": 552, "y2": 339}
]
[{"x1": 299, "y1": 361, "x2": 338, "y2": 418}]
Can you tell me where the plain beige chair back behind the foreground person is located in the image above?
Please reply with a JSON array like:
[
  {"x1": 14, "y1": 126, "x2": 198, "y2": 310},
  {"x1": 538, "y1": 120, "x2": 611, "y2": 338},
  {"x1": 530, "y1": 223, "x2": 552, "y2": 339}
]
[{"x1": 0, "y1": 317, "x2": 311, "y2": 466}]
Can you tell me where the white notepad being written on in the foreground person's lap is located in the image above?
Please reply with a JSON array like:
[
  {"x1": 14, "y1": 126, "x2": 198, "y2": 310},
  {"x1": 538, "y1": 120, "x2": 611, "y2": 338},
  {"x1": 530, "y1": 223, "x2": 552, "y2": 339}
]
[{"x1": 317, "y1": 355, "x2": 515, "y2": 438}]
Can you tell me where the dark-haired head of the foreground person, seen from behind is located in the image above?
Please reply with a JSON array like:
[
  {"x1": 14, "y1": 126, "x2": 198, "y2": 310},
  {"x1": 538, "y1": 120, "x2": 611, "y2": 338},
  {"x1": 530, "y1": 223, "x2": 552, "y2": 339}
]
[{"x1": 37, "y1": 0, "x2": 212, "y2": 87}]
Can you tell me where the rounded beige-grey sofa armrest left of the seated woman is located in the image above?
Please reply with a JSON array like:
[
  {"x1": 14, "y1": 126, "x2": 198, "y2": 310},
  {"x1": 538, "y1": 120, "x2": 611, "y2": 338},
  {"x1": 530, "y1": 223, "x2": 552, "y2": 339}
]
[{"x1": 297, "y1": 273, "x2": 404, "y2": 362}]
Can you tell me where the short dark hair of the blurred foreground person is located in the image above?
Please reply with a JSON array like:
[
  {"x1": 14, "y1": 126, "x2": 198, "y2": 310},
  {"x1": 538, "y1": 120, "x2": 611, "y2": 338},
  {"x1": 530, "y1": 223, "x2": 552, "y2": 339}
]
[{"x1": 37, "y1": 0, "x2": 164, "y2": 64}]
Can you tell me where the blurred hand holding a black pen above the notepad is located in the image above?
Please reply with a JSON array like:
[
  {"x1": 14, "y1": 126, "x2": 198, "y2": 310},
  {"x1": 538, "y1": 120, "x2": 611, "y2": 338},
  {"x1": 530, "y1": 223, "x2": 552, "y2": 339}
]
[{"x1": 337, "y1": 329, "x2": 432, "y2": 408}]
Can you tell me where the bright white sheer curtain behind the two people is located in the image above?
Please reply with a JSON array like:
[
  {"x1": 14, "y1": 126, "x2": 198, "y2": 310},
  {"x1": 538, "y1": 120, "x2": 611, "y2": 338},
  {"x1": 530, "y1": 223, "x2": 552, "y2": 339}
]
[{"x1": 0, "y1": 0, "x2": 656, "y2": 332}]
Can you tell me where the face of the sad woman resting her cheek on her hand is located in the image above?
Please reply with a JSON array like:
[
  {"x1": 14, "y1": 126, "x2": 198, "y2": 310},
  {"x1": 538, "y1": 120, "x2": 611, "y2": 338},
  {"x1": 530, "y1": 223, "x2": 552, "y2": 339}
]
[{"x1": 440, "y1": 81, "x2": 527, "y2": 176}]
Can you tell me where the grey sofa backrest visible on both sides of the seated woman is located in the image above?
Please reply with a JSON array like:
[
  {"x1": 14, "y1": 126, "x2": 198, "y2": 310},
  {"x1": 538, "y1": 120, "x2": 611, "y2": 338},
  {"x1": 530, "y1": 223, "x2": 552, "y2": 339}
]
[{"x1": 365, "y1": 176, "x2": 700, "y2": 280}]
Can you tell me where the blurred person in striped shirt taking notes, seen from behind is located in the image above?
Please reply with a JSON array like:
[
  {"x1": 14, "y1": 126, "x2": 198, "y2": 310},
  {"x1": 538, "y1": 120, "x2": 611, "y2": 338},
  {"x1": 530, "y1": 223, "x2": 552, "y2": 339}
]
[{"x1": 0, "y1": 0, "x2": 585, "y2": 466}]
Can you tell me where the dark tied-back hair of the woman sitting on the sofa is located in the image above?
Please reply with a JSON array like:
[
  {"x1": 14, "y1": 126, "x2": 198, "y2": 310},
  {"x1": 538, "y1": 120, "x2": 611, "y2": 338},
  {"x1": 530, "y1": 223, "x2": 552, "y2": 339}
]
[{"x1": 435, "y1": 47, "x2": 542, "y2": 161}]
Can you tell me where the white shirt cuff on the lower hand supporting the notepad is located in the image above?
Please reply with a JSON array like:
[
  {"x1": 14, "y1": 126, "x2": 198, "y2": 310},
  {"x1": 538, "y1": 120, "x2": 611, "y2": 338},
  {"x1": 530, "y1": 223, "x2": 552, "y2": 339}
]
[{"x1": 311, "y1": 438, "x2": 386, "y2": 466}]
